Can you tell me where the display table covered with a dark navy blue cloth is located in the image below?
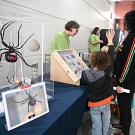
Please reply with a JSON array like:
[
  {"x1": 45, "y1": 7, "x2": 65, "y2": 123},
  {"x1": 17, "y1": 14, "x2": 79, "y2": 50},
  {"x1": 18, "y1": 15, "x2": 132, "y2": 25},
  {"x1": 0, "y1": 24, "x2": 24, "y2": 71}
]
[{"x1": 0, "y1": 83, "x2": 88, "y2": 135}]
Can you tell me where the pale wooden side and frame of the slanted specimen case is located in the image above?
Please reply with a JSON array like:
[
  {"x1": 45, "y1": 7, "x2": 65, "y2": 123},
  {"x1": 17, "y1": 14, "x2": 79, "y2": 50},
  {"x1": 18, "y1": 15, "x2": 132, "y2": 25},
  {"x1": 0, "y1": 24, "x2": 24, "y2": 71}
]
[{"x1": 50, "y1": 49, "x2": 88, "y2": 85}]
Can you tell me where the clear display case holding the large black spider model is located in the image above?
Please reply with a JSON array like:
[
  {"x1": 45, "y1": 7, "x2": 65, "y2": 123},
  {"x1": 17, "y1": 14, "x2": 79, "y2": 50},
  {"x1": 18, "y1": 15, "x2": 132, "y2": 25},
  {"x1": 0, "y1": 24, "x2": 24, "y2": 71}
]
[{"x1": 0, "y1": 17, "x2": 44, "y2": 89}]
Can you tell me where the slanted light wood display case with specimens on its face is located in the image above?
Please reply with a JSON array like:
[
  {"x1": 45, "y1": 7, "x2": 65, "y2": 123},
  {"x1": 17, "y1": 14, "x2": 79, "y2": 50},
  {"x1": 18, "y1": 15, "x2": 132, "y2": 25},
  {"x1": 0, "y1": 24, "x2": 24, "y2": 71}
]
[{"x1": 50, "y1": 48, "x2": 88, "y2": 86}]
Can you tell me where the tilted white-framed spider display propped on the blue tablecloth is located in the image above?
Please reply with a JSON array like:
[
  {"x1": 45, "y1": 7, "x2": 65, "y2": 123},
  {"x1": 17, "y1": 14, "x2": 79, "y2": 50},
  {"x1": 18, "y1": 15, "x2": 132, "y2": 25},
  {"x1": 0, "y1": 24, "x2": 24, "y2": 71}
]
[{"x1": 2, "y1": 83, "x2": 49, "y2": 130}]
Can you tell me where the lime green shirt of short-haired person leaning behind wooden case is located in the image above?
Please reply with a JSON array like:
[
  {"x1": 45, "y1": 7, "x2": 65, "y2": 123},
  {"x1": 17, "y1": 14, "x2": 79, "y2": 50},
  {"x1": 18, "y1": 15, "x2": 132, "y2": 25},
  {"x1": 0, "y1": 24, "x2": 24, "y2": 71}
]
[{"x1": 49, "y1": 31, "x2": 70, "y2": 53}]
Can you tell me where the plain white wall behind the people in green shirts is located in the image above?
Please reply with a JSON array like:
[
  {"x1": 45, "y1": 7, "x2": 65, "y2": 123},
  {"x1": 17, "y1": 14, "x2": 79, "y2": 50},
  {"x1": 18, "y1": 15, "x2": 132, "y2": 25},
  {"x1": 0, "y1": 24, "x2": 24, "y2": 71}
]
[{"x1": 0, "y1": 0, "x2": 113, "y2": 53}]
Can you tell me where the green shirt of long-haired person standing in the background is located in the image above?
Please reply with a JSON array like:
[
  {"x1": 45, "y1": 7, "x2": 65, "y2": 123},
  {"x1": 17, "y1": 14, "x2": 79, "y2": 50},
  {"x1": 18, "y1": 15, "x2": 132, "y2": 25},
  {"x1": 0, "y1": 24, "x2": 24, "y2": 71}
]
[{"x1": 89, "y1": 34, "x2": 100, "y2": 52}]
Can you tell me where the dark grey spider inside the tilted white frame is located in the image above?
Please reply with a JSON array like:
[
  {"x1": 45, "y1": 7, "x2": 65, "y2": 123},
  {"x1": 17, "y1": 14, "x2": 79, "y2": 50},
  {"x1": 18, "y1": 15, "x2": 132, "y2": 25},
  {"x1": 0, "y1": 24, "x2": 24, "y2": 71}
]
[{"x1": 12, "y1": 90, "x2": 42, "y2": 112}]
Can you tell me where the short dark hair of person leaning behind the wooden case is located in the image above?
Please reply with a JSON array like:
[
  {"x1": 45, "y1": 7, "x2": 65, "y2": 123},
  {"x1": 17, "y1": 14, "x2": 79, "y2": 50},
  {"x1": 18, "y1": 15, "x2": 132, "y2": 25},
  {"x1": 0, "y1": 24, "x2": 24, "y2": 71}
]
[{"x1": 65, "y1": 21, "x2": 80, "y2": 31}]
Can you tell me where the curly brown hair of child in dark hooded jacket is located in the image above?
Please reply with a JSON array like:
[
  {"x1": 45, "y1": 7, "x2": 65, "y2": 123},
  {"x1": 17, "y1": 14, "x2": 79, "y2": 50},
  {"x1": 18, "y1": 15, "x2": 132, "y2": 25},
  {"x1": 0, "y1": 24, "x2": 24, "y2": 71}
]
[{"x1": 90, "y1": 51, "x2": 111, "y2": 70}]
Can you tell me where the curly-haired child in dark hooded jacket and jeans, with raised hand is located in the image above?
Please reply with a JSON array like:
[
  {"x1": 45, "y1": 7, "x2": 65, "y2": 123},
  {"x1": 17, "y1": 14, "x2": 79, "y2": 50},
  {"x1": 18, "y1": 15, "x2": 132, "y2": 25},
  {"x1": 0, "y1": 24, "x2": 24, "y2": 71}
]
[{"x1": 81, "y1": 31, "x2": 114, "y2": 135}]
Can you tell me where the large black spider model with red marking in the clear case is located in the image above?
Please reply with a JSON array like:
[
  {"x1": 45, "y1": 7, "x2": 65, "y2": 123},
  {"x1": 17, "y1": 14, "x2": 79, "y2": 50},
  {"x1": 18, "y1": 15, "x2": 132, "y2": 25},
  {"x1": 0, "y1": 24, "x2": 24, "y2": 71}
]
[{"x1": 0, "y1": 21, "x2": 34, "y2": 67}]
